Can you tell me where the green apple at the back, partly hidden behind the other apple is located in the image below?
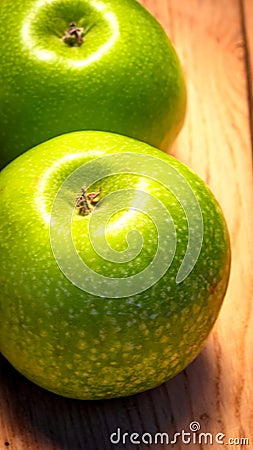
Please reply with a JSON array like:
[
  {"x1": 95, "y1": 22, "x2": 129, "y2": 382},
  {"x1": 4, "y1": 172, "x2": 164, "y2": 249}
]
[{"x1": 0, "y1": 0, "x2": 186, "y2": 167}]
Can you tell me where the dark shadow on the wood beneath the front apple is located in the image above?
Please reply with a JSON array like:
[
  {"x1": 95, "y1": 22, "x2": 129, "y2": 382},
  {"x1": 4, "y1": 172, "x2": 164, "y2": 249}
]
[{"x1": 0, "y1": 345, "x2": 227, "y2": 450}]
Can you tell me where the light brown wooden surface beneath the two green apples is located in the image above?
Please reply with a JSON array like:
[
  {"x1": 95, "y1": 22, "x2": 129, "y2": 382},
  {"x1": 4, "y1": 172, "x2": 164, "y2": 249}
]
[{"x1": 0, "y1": 0, "x2": 253, "y2": 450}]
